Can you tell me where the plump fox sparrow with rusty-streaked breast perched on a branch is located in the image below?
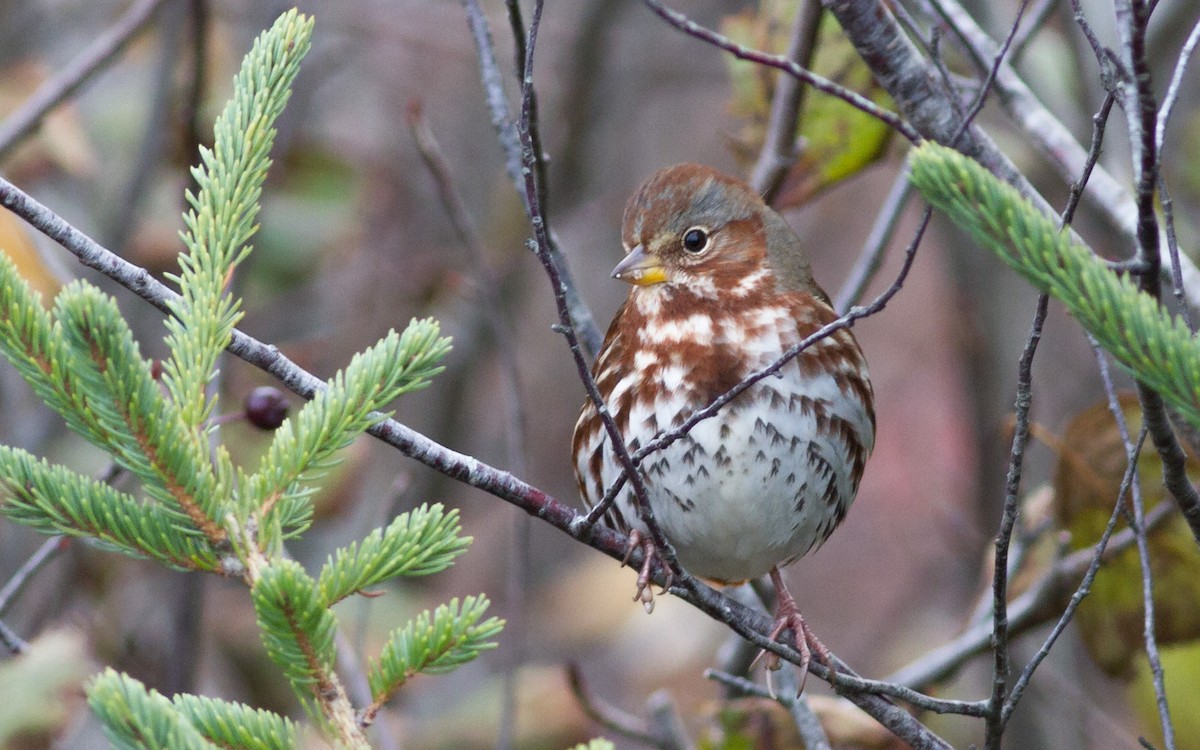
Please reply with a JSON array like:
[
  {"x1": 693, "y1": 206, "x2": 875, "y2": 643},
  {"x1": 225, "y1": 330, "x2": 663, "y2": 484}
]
[{"x1": 574, "y1": 164, "x2": 875, "y2": 665}]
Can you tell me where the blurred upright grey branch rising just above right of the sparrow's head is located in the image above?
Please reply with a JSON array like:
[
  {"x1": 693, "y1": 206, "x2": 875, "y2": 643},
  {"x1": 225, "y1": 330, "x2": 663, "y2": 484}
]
[{"x1": 749, "y1": 0, "x2": 823, "y2": 205}]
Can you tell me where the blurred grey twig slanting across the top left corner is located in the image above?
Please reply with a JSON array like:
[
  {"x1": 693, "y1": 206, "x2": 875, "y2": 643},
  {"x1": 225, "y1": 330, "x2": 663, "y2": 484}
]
[{"x1": 0, "y1": 0, "x2": 163, "y2": 160}]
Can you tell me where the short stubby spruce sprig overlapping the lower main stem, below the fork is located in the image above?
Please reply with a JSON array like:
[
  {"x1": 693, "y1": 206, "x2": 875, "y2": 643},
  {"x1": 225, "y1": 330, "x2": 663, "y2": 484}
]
[{"x1": 251, "y1": 559, "x2": 337, "y2": 698}]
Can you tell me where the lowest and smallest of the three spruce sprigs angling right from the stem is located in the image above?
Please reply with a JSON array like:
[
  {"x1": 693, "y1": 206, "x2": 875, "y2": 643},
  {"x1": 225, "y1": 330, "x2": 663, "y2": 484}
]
[{"x1": 367, "y1": 596, "x2": 504, "y2": 706}]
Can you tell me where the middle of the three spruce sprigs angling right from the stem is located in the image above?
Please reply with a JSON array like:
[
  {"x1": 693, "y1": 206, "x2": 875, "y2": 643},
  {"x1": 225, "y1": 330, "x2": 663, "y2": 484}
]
[{"x1": 317, "y1": 504, "x2": 472, "y2": 606}]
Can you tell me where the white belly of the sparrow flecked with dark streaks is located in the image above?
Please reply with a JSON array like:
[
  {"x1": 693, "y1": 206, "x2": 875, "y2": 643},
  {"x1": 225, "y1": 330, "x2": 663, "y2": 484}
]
[{"x1": 602, "y1": 362, "x2": 868, "y2": 582}]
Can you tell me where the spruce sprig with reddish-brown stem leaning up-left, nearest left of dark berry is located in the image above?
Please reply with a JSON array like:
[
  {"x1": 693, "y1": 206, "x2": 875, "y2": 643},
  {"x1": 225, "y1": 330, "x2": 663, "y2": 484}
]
[{"x1": 55, "y1": 282, "x2": 228, "y2": 541}]
